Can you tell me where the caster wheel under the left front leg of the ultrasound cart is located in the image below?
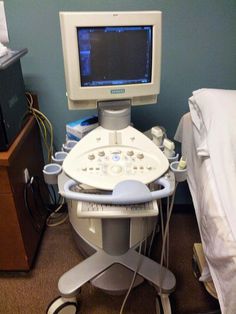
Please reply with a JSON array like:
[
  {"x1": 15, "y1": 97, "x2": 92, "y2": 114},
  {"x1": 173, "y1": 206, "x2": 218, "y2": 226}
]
[{"x1": 46, "y1": 297, "x2": 79, "y2": 314}]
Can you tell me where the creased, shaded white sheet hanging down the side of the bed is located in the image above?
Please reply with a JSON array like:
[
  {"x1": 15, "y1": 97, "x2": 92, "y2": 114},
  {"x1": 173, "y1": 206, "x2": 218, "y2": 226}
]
[{"x1": 175, "y1": 113, "x2": 236, "y2": 314}]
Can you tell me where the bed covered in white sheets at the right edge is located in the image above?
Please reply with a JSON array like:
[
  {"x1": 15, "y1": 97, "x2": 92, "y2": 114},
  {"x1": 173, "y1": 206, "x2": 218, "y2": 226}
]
[{"x1": 175, "y1": 89, "x2": 236, "y2": 314}]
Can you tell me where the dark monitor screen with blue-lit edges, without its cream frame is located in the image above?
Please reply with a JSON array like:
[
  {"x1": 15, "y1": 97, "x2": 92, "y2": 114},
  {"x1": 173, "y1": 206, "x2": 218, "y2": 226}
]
[{"x1": 77, "y1": 26, "x2": 152, "y2": 87}]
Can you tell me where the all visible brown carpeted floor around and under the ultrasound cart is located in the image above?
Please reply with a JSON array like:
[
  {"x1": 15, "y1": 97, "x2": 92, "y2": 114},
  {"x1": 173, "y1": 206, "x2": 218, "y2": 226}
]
[{"x1": 0, "y1": 207, "x2": 218, "y2": 314}]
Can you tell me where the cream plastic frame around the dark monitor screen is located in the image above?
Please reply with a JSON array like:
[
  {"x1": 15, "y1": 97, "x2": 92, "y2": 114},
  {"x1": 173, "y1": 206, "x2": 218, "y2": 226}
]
[{"x1": 59, "y1": 11, "x2": 162, "y2": 109}]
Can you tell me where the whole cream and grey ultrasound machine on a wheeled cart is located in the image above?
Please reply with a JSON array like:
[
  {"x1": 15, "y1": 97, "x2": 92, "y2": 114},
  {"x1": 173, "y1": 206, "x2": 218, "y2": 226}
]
[{"x1": 47, "y1": 11, "x2": 176, "y2": 314}]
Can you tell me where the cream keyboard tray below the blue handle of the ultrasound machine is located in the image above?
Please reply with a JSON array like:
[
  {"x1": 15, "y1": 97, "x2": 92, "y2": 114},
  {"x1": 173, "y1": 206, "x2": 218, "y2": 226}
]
[{"x1": 77, "y1": 200, "x2": 158, "y2": 218}]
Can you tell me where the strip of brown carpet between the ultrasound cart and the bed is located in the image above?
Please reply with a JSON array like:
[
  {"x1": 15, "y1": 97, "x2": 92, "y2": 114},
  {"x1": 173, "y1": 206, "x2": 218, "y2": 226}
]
[{"x1": 166, "y1": 211, "x2": 219, "y2": 314}]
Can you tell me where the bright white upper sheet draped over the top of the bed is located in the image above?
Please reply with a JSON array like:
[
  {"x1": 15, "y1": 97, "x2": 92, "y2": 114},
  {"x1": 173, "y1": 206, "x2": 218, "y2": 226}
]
[{"x1": 189, "y1": 88, "x2": 236, "y2": 240}]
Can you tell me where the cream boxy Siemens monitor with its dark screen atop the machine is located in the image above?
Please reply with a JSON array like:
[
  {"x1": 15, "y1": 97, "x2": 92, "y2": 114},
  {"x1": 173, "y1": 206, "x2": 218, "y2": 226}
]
[{"x1": 60, "y1": 11, "x2": 161, "y2": 109}]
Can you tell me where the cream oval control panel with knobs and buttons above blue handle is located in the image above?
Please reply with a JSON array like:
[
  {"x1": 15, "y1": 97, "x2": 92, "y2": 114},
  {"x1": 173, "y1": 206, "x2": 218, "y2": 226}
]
[{"x1": 63, "y1": 124, "x2": 169, "y2": 190}]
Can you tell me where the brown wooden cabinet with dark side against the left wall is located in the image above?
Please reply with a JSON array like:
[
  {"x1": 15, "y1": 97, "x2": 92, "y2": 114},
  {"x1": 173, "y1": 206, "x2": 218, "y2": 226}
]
[{"x1": 0, "y1": 117, "x2": 46, "y2": 271}]
